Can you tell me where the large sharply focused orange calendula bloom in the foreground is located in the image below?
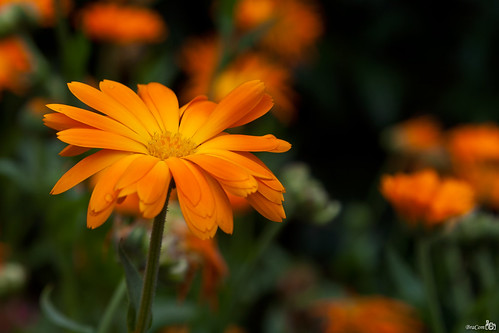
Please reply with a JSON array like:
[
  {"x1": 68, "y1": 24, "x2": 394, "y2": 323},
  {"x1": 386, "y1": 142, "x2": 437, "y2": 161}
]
[{"x1": 44, "y1": 80, "x2": 291, "y2": 238}]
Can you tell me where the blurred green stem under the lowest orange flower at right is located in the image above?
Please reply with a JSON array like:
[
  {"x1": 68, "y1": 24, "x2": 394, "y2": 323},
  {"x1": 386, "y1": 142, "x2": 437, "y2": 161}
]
[{"x1": 417, "y1": 236, "x2": 445, "y2": 333}]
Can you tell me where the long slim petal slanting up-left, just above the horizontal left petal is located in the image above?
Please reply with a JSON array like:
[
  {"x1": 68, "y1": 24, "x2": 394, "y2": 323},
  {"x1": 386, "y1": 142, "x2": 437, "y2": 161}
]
[{"x1": 47, "y1": 104, "x2": 146, "y2": 144}]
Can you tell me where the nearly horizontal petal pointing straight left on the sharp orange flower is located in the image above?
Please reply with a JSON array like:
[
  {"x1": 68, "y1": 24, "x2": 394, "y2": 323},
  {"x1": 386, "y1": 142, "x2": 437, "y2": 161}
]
[{"x1": 57, "y1": 128, "x2": 147, "y2": 154}]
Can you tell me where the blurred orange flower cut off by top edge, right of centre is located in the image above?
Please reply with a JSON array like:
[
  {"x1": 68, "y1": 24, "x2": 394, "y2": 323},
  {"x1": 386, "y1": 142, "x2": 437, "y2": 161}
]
[{"x1": 235, "y1": 0, "x2": 323, "y2": 61}]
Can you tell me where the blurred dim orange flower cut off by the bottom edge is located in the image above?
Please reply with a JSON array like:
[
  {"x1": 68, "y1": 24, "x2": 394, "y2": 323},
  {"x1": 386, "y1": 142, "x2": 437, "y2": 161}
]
[{"x1": 312, "y1": 296, "x2": 423, "y2": 333}]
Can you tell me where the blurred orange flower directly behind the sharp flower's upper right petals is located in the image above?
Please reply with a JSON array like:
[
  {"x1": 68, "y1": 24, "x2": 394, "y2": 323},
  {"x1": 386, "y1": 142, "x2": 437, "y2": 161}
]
[{"x1": 182, "y1": 38, "x2": 296, "y2": 123}]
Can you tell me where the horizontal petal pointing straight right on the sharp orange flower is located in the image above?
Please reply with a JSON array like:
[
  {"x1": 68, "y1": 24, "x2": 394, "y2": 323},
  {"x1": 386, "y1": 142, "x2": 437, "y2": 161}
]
[{"x1": 198, "y1": 134, "x2": 291, "y2": 153}]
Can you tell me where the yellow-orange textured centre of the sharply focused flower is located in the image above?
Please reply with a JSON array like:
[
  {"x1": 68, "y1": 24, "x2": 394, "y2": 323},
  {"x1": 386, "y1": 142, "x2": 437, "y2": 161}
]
[{"x1": 147, "y1": 131, "x2": 197, "y2": 160}]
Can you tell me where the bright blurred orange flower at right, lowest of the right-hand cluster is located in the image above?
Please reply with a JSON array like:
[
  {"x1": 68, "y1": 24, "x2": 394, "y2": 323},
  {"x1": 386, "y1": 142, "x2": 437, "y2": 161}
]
[{"x1": 381, "y1": 170, "x2": 474, "y2": 226}]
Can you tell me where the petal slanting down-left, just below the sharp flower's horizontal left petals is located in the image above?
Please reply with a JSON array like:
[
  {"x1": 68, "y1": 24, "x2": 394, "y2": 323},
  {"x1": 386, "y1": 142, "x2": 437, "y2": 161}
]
[{"x1": 50, "y1": 150, "x2": 130, "y2": 194}]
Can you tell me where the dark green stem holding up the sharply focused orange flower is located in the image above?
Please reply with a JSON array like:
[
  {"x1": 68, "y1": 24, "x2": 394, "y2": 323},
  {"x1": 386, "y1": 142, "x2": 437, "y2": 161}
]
[{"x1": 135, "y1": 180, "x2": 174, "y2": 333}]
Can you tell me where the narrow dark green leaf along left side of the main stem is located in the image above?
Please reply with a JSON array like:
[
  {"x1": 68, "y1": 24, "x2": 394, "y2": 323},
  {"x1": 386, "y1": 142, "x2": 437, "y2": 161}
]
[{"x1": 118, "y1": 242, "x2": 143, "y2": 332}]
